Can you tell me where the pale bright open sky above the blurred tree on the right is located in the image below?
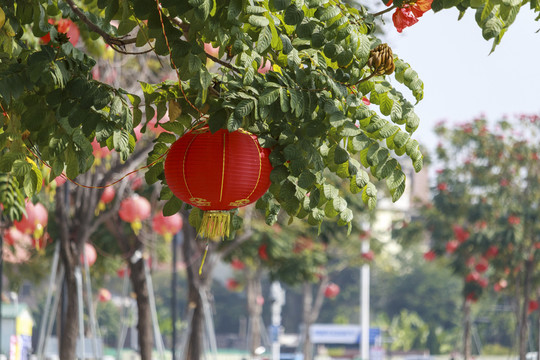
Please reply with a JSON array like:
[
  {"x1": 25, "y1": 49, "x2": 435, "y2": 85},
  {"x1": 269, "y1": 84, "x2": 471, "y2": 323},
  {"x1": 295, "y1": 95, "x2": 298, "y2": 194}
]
[{"x1": 378, "y1": 5, "x2": 540, "y2": 150}]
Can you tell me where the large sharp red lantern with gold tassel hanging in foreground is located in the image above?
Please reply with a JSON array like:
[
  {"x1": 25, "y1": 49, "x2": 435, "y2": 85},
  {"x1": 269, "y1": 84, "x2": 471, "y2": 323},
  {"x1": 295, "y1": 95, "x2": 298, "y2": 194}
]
[{"x1": 165, "y1": 126, "x2": 272, "y2": 237}]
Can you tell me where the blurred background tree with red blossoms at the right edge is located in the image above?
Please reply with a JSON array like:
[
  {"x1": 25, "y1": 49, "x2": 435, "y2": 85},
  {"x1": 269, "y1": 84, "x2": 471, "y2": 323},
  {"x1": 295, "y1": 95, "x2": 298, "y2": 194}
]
[{"x1": 395, "y1": 115, "x2": 540, "y2": 359}]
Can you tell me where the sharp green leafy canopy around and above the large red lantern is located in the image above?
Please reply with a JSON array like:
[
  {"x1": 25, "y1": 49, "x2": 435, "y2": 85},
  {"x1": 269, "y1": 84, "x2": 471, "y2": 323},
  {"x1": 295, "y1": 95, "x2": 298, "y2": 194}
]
[{"x1": 0, "y1": 0, "x2": 423, "y2": 231}]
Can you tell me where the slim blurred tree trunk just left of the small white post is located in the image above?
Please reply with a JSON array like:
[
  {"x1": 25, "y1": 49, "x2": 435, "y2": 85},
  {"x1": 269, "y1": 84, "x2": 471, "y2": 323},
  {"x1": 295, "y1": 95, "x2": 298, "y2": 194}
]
[{"x1": 246, "y1": 270, "x2": 262, "y2": 356}]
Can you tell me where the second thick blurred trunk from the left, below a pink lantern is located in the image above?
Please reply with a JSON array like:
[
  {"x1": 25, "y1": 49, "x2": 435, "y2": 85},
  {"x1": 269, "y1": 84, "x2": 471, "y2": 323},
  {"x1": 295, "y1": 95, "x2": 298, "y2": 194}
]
[{"x1": 129, "y1": 253, "x2": 154, "y2": 360}]
